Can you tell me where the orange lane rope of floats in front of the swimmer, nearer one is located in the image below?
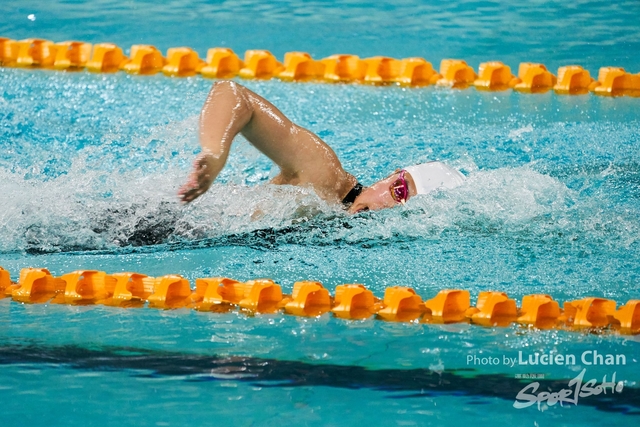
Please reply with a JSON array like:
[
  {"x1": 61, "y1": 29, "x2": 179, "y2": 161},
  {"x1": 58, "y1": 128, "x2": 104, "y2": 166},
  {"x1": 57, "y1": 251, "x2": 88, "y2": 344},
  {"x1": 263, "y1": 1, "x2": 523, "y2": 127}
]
[{"x1": 0, "y1": 267, "x2": 640, "y2": 335}]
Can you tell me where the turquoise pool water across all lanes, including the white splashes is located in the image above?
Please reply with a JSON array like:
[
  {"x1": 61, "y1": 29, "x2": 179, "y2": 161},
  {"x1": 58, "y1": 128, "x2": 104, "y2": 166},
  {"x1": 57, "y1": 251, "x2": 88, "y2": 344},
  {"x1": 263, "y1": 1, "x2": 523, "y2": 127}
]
[{"x1": 0, "y1": 1, "x2": 640, "y2": 426}]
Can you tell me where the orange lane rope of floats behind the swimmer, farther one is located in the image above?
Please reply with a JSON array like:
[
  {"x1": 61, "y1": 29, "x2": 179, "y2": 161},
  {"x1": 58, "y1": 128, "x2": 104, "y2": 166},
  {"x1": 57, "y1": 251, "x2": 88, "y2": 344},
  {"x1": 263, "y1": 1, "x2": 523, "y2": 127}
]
[{"x1": 0, "y1": 37, "x2": 640, "y2": 97}]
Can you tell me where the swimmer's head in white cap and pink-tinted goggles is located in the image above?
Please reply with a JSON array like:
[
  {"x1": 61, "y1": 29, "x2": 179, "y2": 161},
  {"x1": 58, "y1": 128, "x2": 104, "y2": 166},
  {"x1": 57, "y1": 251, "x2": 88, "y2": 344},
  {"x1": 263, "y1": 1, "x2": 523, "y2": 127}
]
[{"x1": 349, "y1": 162, "x2": 465, "y2": 213}]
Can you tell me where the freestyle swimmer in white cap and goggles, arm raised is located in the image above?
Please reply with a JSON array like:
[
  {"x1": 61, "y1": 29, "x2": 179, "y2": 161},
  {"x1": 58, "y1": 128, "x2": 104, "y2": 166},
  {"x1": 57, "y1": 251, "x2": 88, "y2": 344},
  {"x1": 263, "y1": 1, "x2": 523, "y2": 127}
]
[{"x1": 178, "y1": 81, "x2": 464, "y2": 213}]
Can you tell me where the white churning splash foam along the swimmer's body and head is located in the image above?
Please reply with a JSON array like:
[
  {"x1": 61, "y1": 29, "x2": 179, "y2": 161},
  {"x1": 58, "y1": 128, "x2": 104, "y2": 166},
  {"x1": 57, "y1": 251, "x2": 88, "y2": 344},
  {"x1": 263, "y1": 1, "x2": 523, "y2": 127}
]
[{"x1": 5, "y1": 140, "x2": 637, "y2": 252}]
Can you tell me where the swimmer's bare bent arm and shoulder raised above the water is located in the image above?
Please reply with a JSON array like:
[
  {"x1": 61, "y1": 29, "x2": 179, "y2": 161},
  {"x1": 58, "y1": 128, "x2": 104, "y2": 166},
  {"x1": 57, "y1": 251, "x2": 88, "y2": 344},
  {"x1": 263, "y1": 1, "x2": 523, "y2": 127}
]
[{"x1": 178, "y1": 81, "x2": 356, "y2": 203}]
